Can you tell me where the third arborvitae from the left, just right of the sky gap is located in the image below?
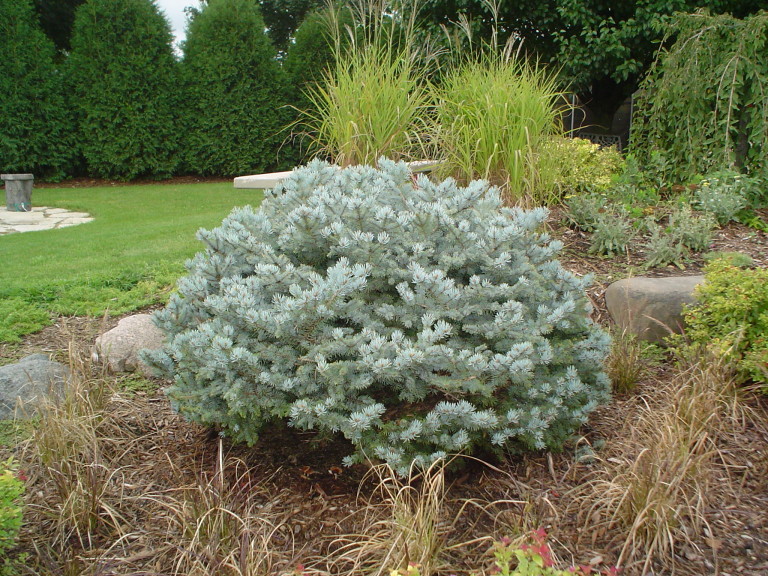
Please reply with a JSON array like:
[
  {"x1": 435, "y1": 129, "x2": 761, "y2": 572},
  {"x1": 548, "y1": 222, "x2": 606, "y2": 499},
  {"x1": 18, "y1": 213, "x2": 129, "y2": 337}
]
[{"x1": 182, "y1": 0, "x2": 292, "y2": 176}]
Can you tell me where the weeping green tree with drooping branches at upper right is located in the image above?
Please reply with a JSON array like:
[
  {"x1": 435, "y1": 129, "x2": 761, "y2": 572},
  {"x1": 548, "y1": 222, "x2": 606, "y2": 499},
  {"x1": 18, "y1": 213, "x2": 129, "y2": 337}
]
[{"x1": 632, "y1": 11, "x2": 768, "y2": 182}]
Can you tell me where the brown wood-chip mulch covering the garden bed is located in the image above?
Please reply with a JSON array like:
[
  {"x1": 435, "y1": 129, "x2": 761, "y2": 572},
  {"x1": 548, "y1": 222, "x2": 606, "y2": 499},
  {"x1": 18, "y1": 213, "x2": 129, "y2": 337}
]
[{"x1": 0, "y1": 214, "x2": 768, "y2": 576}]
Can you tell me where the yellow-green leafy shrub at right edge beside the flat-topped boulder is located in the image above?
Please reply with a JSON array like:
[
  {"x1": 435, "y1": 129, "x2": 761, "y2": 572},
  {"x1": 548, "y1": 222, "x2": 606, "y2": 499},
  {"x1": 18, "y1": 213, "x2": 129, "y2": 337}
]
[{"x1": 677, "y1": 261, "x2": 768, "y2": 390}]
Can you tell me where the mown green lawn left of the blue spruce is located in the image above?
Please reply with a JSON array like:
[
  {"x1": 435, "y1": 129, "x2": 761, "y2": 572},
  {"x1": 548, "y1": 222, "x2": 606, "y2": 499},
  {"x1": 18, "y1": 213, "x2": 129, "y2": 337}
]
[{"x1": 0, "y1": 182, "x2": 263, "y2": 341}]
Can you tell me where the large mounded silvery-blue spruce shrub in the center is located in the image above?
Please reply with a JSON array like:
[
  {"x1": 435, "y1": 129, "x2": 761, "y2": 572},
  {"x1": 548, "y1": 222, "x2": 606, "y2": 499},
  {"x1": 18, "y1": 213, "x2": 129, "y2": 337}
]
[{"x1": 147, "y1": 159, "x2": 609, "y2": 473}]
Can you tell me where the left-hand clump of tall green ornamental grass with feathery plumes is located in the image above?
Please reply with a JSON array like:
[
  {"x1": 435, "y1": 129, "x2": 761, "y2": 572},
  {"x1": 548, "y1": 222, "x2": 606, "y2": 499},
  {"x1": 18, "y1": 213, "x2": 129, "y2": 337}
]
[{"x1": 296, "y1": 0, "x2": 432, "y2": 166}]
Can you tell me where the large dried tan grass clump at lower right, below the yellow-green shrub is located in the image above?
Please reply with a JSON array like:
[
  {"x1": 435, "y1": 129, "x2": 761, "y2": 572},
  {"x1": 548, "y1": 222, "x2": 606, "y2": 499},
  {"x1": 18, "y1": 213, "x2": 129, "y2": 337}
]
[{"x1": 569, "y1": 348, "x2": 750, "y2": 574}]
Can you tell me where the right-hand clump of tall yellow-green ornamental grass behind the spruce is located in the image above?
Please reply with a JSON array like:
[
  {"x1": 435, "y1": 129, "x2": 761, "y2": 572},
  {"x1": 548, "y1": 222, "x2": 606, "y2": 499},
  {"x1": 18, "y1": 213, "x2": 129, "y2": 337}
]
[{"x1": 433, "y1": 44, "x2": 567, "y2": 203}]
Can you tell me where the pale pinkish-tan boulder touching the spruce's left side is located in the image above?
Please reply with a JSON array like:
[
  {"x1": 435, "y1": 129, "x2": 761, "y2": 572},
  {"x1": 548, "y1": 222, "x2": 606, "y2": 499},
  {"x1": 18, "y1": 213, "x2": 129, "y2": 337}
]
[{"x1": 93, "y1": 314, "x2": 165, "y2": 375}]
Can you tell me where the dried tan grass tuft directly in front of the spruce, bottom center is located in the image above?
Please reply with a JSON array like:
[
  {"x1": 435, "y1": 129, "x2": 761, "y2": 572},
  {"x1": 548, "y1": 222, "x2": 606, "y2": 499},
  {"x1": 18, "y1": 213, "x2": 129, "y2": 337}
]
[{"x1": 316, "y1": 457, "x2": 532, "y2": 576}]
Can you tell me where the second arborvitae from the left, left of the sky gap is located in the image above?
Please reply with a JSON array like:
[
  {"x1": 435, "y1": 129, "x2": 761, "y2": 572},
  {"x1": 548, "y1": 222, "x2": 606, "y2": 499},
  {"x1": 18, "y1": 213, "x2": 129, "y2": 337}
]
[{"x1": 68, "y1": 0, "x2": 179, "y2": 180}]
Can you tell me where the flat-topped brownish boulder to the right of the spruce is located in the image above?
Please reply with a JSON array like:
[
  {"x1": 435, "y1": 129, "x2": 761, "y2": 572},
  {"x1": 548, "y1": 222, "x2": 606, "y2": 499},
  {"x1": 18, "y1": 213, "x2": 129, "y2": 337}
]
[{"x1": 605, "y1": 276, "x2": 704, "y2": 343}]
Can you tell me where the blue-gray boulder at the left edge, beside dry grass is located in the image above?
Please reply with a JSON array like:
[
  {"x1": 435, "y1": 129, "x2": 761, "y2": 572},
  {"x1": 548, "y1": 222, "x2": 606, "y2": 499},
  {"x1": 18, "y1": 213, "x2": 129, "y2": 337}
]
[{"x1": 0, "y1": 354, "x2": 69, "y2": 420}]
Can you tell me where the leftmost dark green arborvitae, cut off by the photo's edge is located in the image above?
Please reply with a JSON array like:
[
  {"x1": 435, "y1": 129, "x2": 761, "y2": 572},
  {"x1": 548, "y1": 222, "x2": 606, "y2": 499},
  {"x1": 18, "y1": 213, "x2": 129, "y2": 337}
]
[{"x1": 0, "y1": 0, "x2": 73, "y2": 178}]
